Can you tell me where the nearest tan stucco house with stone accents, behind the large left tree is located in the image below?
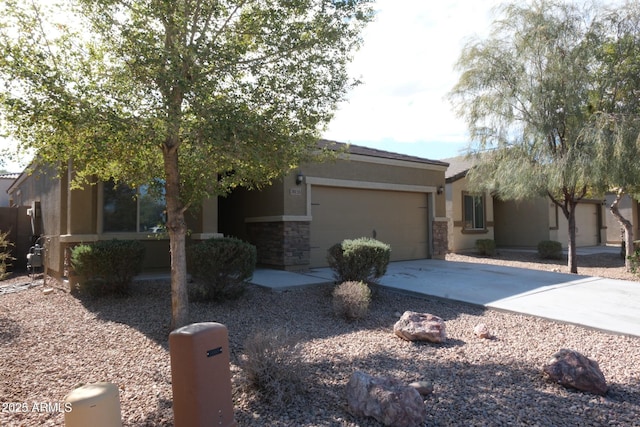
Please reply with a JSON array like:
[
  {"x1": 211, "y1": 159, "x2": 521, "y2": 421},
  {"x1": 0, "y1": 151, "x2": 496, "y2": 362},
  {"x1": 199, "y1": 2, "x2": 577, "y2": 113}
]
[{"x1": 9, "y1": 141, "x2": 447, "y2": 277}]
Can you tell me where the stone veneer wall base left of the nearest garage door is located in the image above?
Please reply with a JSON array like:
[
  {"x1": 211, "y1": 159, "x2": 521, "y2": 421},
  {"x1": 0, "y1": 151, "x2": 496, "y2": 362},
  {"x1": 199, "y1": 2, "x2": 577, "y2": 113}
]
[{"x1": 246, "y1": 221, "x2": 311, "y2": 270}]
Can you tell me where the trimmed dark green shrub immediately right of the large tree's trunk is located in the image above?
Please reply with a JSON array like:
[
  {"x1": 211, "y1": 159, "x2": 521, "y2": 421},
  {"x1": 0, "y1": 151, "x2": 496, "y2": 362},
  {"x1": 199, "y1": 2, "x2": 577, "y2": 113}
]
[{"x1": 187, "y1": 237, "x2": 257, "y2": 301}]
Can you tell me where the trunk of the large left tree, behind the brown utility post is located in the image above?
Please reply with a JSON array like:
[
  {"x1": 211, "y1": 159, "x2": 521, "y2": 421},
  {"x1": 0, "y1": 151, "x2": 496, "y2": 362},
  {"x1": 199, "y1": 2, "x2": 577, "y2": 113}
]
[{"x1": 163, "y1": 146, "x2": 189, "y2": 330}]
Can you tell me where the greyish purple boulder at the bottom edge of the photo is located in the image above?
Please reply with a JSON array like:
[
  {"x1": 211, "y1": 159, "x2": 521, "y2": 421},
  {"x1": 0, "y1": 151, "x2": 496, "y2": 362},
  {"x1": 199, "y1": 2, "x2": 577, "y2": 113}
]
[{"x1": 346, "y1": 371, "x2": 427, "y2": 427}]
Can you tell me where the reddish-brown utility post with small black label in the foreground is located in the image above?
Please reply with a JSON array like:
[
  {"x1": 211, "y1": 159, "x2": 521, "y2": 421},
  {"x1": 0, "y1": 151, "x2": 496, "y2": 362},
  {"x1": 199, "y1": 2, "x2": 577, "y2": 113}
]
[{"x1": 169, "y1": 322, "x2": 237, "y2": 427}]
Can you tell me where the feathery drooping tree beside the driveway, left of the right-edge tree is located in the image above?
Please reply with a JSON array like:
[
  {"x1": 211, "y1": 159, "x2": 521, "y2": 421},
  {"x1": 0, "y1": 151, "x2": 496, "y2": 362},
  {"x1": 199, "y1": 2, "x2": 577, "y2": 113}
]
[{"x1": 449, "y1": 0, "x2": 595, "y2": 273}]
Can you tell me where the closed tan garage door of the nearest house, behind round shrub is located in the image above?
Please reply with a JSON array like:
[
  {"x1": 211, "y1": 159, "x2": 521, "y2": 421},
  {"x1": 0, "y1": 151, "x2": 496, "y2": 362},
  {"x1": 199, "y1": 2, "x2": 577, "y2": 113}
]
[{"x1": 310, "y1": 185, "x2": 429, "y2": 267}]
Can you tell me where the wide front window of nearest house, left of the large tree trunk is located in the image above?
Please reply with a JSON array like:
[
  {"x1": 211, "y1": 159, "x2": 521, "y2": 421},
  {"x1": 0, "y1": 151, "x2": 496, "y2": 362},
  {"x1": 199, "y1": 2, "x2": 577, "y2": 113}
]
[{"x1": 102, "y1": 181, "x2": 165, "y2": 233}]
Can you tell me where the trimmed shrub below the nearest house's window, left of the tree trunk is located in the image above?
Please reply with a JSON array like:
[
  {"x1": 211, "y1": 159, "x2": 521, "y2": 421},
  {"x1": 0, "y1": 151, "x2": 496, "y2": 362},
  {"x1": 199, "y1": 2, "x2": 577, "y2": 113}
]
[{"x1": 71, "y1": 239, "x2": 145, "y2": 296}]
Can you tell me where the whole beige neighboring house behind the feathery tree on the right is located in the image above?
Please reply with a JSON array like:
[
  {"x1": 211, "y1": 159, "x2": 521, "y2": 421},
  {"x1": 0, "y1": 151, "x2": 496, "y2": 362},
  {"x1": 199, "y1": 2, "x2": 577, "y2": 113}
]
[{"x1": 443, "y1": 157, "x2": 607, "y2": 252}]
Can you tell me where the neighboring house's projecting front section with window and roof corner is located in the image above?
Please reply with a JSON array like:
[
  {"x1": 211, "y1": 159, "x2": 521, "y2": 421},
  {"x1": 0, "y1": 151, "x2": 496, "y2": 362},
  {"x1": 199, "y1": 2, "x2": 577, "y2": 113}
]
[{"x1": 443, "y1": 156, "x2": 495, "y2": 252}]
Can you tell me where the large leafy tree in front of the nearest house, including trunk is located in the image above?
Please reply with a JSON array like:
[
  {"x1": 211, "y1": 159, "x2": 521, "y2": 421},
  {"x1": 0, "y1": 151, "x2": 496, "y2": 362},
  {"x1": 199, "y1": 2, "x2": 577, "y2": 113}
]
[{"x1": 0, "y1": 0, "x2": 372, "y2": 327}]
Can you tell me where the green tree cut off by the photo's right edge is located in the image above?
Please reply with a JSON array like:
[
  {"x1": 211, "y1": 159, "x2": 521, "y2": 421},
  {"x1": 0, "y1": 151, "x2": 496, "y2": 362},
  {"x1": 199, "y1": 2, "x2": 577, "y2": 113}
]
[{"x1": 583, "y1": 2, "x2": 640, "y2": 270}]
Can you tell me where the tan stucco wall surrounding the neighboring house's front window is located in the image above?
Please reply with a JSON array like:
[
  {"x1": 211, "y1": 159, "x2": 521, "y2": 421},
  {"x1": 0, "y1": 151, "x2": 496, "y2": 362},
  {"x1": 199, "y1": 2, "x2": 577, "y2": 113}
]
[{"x1": 446, "y1": 178, "x2": 495, "y2": 252}]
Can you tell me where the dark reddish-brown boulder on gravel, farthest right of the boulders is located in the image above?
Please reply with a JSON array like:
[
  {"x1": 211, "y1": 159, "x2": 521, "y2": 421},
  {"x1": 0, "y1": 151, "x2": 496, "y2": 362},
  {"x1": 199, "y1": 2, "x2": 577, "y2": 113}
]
[{"x1": 542, "y1": 349, "x2": 608, "y2": 395}]
